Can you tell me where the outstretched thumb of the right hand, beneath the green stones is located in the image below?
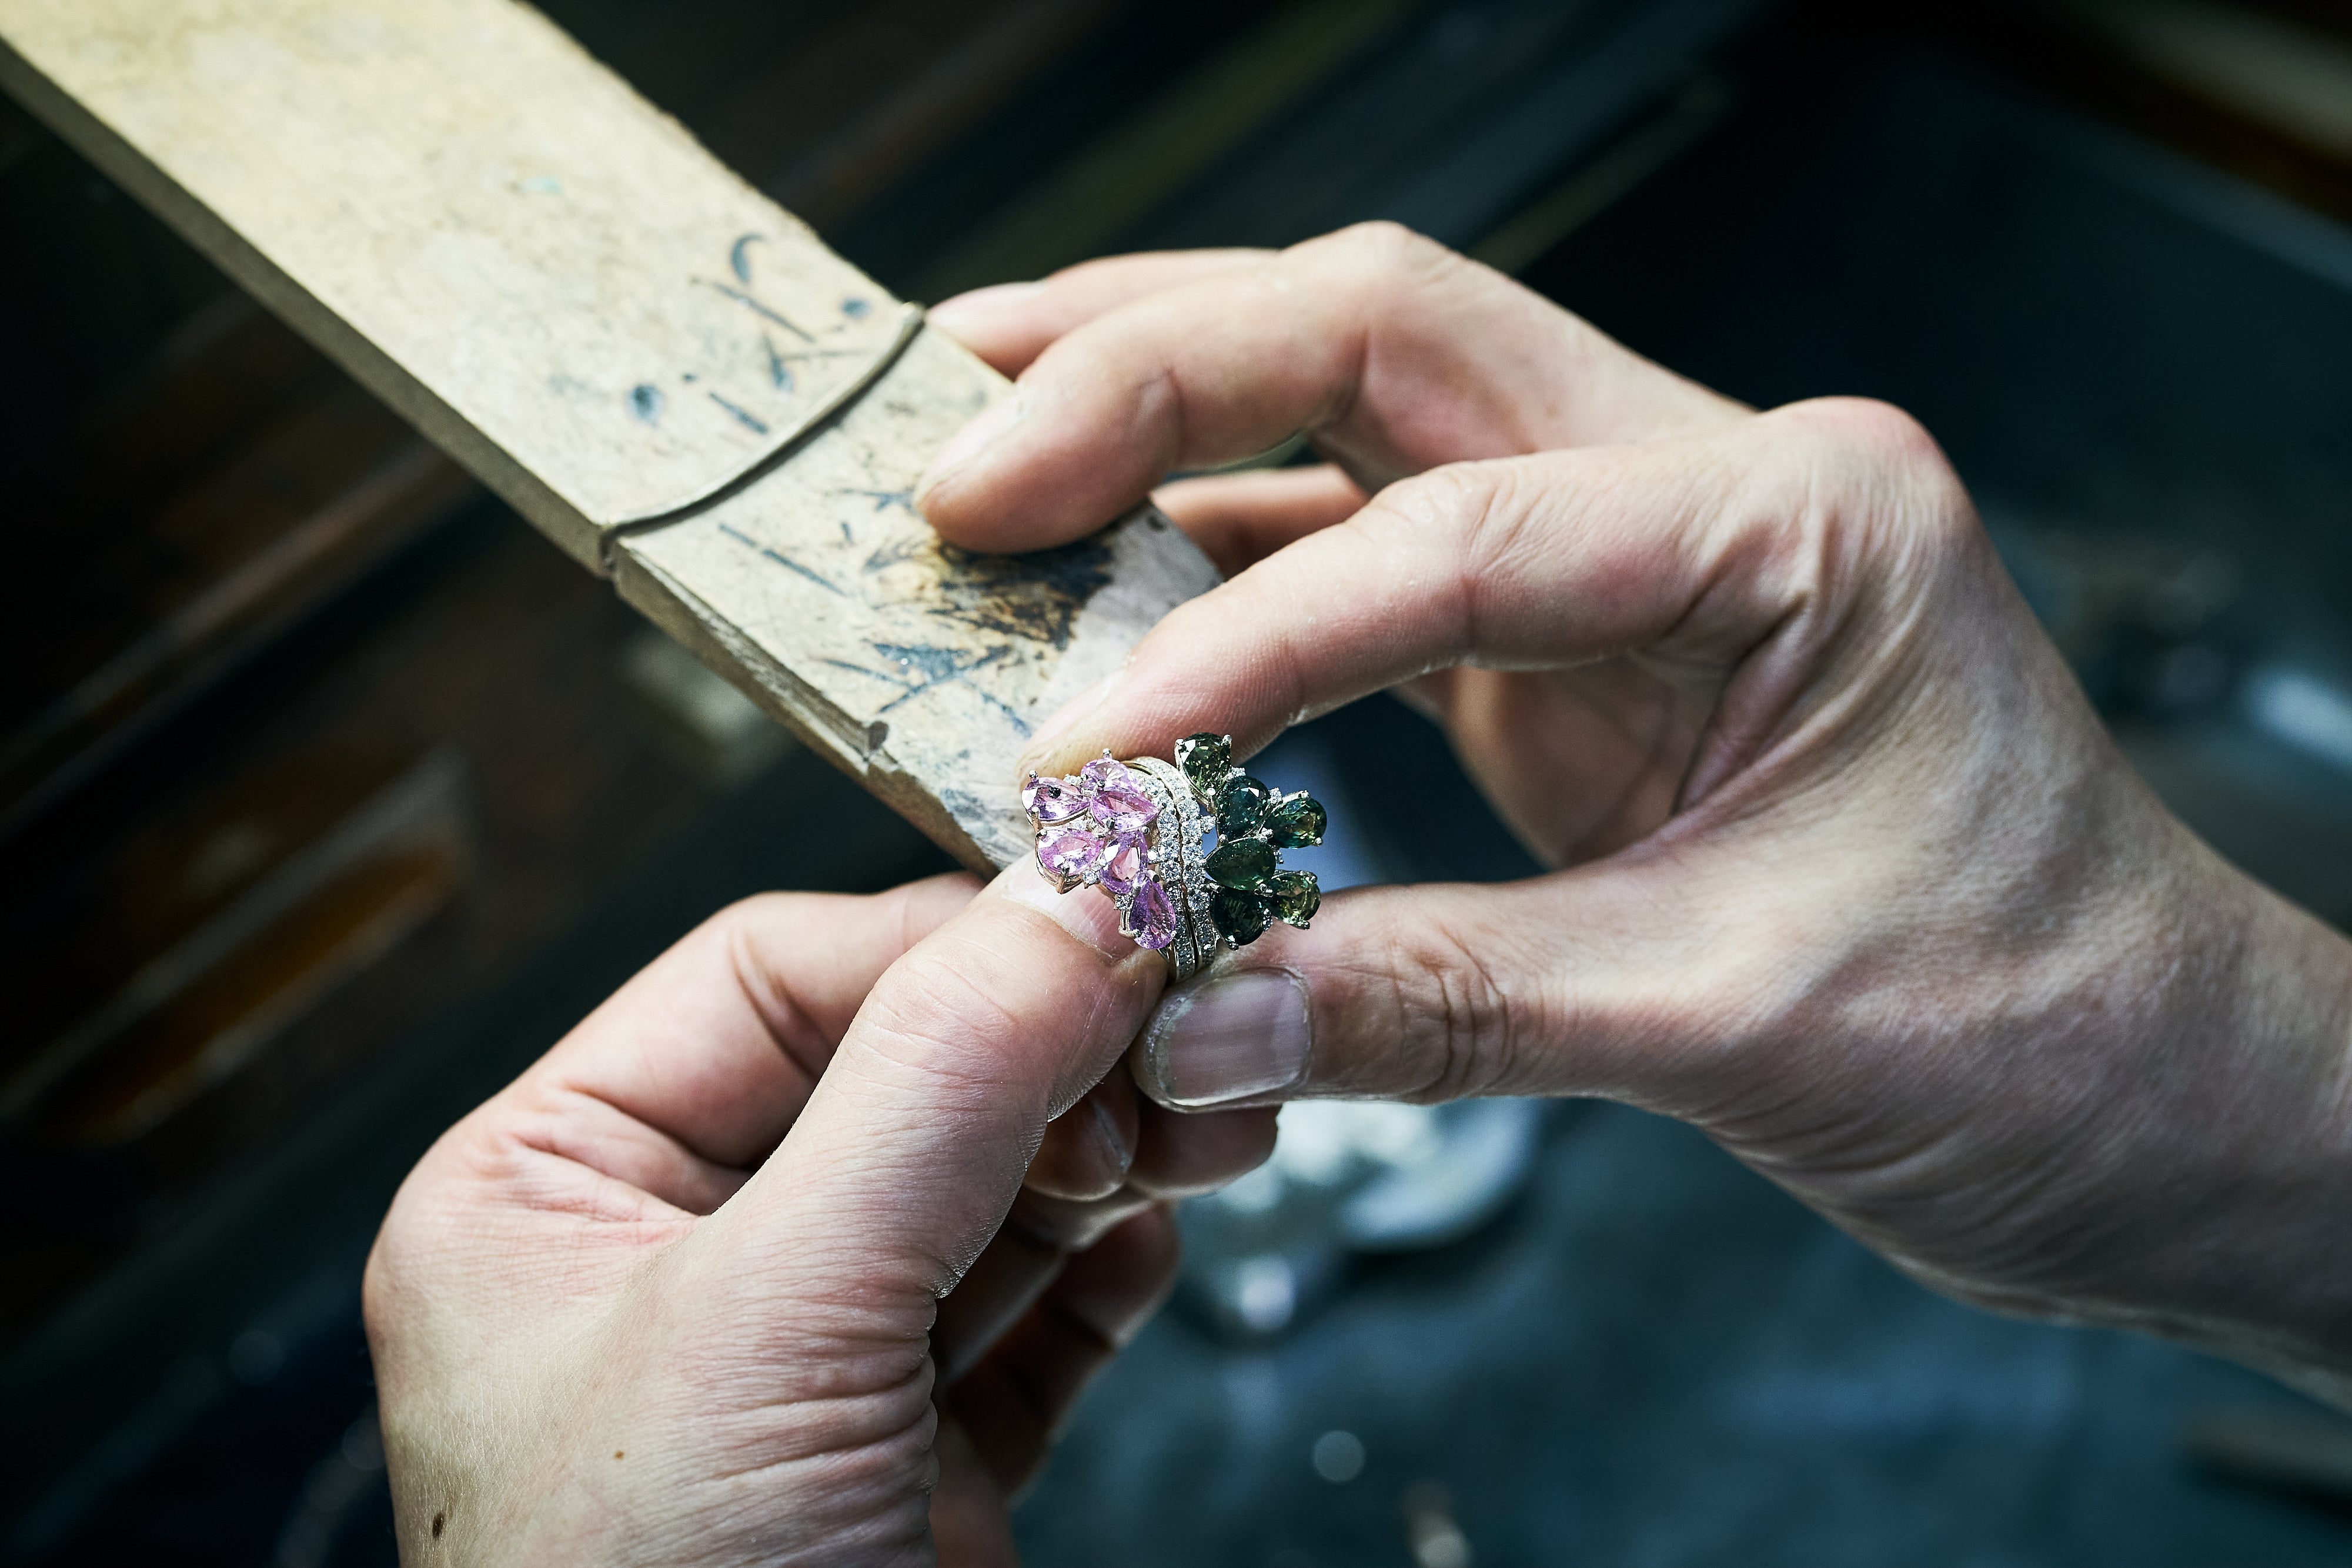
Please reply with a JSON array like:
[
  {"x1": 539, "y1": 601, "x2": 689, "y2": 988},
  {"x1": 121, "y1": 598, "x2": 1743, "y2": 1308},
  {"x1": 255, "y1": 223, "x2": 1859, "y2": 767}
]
[{"x1": 1129, "y1": 860, "x2": 1835, "y2": 1114}]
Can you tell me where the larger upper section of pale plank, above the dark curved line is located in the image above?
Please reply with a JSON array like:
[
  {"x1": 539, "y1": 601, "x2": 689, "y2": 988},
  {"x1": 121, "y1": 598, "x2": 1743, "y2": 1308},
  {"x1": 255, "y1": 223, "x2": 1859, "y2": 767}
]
[{"x1": 0, "y1": 0, "x2": 903, "y2": 562}]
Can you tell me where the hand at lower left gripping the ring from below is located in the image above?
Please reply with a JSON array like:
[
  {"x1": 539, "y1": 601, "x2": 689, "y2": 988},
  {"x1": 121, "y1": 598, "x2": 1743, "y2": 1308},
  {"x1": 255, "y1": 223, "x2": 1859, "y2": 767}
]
[{"x1": 367, "y1": 867, "x2": 1272, "y2": 1568}]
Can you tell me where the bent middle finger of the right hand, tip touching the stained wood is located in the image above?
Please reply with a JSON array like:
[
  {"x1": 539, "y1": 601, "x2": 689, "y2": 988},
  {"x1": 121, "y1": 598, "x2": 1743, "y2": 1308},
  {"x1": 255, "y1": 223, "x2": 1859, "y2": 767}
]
[{"x1": 917, "y1": 223, "x2": 1743, "y2": 550}]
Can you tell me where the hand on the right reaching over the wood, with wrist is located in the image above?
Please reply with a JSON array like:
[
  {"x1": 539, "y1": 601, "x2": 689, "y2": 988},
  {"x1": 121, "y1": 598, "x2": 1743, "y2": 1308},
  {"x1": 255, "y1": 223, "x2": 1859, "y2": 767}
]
[{"x1": 920, "y1": 226, "x2": 2352, "y2": 1394}]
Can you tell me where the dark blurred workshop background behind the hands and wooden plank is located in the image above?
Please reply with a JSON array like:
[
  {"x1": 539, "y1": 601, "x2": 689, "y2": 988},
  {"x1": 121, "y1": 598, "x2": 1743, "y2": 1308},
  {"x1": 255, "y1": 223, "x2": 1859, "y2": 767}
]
[{"x1": 0, "y1": 0, "x2": 2352, "y2": 1568}]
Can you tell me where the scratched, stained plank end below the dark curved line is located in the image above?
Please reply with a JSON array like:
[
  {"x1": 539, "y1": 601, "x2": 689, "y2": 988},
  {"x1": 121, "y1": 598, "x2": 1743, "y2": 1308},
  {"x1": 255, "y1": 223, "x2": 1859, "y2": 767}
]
[{"x1": 616, "y1": 329, "x2": 1216, "y2": 865}]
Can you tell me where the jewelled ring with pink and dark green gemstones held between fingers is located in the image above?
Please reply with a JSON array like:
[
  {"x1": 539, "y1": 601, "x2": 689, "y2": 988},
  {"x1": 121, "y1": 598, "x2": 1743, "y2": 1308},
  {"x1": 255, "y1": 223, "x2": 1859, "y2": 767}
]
[{"x1": 1021, "y1": 734, "x2": 1327, "y2": 980}]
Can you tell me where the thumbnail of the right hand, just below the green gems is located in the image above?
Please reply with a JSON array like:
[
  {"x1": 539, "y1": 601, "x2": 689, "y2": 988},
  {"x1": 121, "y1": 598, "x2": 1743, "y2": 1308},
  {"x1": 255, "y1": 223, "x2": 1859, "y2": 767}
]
[{"x1": 1141, "y1": 968, "x2": 1310, "y2": 1105}]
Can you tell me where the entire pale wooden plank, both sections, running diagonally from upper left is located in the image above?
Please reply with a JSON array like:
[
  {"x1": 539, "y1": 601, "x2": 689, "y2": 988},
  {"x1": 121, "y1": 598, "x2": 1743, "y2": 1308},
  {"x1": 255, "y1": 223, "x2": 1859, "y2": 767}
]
[{"x1": 0, "y1": 0, "x2": 1214, "y2": 867}]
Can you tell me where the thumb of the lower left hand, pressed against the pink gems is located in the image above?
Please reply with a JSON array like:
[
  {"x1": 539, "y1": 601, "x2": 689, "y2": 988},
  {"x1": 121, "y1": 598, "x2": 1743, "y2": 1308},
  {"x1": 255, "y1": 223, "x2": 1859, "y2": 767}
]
[{"x1": 691, "y1": 860, "x2": 1167, "y2": 1363}]
